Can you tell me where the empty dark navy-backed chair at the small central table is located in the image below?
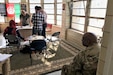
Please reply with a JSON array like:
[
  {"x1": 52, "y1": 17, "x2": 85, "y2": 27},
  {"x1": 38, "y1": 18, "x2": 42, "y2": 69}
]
[{"x1": 30, "y1": 40, "x2": 46, "y2": 64}]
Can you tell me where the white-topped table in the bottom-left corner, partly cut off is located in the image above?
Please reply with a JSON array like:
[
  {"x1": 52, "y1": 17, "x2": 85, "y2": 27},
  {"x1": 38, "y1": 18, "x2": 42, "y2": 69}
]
[{"x1": 0, "y1": 54, "x2": 12, "y2": 75}]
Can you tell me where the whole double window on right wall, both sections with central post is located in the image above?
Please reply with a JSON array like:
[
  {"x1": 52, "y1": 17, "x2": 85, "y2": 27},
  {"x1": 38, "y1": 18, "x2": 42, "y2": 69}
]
[{"x1": 71, "y1": 0, "x2": 107, "y2": 36}]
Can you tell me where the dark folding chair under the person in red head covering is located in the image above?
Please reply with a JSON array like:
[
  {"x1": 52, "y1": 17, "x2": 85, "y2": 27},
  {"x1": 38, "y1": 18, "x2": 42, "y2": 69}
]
[{"x1": 5, "y1": 35, "x2": 20, "y2": 53}]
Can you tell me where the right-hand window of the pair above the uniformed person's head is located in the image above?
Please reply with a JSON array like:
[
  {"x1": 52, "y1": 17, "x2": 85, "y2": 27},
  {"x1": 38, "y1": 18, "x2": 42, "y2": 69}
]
[{"x1": 88, "y1": 0, "x2": 107, "y2": 36}]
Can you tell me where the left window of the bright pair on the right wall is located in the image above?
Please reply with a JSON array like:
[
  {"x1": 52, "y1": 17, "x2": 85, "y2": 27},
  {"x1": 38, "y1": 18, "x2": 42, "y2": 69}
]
[{"x1": 70, "y1": 1, "x2": 86, "y2": 32}]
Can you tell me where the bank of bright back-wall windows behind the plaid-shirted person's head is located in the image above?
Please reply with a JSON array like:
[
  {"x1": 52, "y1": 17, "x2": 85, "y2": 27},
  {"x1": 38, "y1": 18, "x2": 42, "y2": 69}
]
[{"x1": 29, "y1": 0, "x2": 62, "y2": 26}]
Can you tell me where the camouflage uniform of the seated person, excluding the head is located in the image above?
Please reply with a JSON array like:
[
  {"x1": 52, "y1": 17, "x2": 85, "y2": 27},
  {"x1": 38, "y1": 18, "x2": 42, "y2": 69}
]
[{"x1": 61, "y1": 44, "x2": 100, "y2": 75}]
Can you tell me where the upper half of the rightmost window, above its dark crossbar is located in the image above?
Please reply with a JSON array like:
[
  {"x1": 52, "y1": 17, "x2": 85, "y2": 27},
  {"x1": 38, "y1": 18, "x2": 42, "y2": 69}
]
[{"x1": 90, "y1": 0, "x2": 108, "y2": 18}]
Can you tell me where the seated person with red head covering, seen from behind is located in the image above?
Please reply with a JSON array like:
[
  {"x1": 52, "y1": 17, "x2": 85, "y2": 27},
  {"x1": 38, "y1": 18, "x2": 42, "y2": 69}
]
[{"x1": 3, "y1": 20, "x2": 25, "y2": 41}]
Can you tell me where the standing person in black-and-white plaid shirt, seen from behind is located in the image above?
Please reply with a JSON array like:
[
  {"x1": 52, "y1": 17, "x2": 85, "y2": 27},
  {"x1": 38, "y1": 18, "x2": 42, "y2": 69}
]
[{"x1": 31, "y1": 6, "x2": 45, "y2": 35}]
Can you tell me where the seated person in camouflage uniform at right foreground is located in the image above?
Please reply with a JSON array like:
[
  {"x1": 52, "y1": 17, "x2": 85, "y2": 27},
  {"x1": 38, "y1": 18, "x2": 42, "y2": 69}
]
[{"x1": 61, "y1": 32, "x2": 100, "y2": 75}]
